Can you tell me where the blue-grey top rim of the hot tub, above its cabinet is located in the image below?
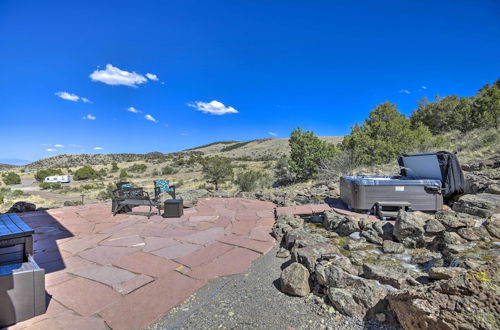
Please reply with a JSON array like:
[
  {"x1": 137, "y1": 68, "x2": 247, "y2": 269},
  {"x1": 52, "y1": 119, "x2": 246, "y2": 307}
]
[{"x1": 343, "y1": 175, "x2": 441, "y2": 187}]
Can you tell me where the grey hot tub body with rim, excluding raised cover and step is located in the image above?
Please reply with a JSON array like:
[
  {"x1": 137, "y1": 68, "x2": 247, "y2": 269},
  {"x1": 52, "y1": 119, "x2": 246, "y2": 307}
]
[{"x1": 340, "y1": 176, "x2": 443, "y2": 212}]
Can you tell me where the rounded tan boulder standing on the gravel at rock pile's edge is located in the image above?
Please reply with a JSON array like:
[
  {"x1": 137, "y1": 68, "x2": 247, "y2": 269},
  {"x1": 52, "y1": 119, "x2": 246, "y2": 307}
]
[{"x1": 280, "y1": 262, "x2": 311, "y2": 297}]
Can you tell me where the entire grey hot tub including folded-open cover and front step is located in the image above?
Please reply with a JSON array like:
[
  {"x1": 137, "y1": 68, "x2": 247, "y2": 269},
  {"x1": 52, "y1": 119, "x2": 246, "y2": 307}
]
[{"x1": 340, "y1": 151, "x2": 465, "y2": 218}]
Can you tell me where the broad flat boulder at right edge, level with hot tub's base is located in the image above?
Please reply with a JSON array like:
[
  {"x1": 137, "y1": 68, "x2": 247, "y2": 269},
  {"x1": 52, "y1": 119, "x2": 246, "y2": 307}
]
[{"x1": 453, "y1": 193, "x2": 500, "y2": 218}]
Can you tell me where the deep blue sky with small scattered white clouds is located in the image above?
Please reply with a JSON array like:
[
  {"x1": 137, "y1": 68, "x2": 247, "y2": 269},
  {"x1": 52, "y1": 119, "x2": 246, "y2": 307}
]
[{"x1": 0, "y1": 0, "x2": 500, "y2": 160}]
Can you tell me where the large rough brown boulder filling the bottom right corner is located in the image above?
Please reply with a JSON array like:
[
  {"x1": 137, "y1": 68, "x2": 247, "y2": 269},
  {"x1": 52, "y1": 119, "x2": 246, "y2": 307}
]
[{"x1": 387, "y1": 263, "x2": 500, "y2": 330}]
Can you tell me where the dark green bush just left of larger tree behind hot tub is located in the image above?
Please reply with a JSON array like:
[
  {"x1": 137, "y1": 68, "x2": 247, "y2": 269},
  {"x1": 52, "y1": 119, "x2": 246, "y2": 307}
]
[{"x1": 289, "y1": 127, "x2": 338, "y2": 181}]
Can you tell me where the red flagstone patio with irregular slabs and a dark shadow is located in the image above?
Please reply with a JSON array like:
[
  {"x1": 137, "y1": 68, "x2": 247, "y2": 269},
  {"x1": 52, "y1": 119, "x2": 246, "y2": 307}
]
[{"x1": 4, "y1": 198, "x2": 275, "y2": 329}]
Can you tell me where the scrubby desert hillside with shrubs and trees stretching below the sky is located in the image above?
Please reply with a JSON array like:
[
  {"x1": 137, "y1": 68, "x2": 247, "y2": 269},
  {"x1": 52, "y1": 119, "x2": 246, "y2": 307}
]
[{"x1": 0, "y1": 77, "x2": 500, "y2": 209}]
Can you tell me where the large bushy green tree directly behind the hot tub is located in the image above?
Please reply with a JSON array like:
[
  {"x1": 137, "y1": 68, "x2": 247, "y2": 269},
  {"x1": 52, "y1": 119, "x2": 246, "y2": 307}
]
[{"x1": 342, "y1": 102, "x2": 432, "y2": 165}]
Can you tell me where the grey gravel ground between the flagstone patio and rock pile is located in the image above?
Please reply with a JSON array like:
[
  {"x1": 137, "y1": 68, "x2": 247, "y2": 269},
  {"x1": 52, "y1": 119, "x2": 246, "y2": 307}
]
[{"x1": 148, "y1": 247, "x2": 396, "y2": 329}]
